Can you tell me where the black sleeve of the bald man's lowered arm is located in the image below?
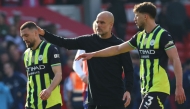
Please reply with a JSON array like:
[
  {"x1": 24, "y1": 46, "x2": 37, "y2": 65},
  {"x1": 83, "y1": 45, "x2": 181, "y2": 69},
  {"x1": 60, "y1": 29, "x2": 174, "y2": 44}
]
[{"x1": 121, "y1": 52, "x2": 134, "y2": 93}]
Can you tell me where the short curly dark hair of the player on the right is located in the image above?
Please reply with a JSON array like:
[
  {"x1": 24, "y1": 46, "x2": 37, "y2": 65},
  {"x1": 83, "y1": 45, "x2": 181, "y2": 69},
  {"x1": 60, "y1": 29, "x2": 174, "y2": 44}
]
[{"x1": 133, "y1": 2, "x2": 156, "y2": 19}]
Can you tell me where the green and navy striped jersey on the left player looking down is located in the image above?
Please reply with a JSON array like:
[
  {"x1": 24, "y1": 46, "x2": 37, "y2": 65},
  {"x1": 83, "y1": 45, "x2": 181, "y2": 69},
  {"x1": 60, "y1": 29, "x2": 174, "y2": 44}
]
[{"x1": 24, "y1": 41, "x2": 62, "y2": 109}]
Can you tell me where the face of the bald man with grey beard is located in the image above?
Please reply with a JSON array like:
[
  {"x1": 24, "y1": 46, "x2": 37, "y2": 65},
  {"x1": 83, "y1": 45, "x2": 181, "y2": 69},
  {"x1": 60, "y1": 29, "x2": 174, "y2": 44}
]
[{"x1": 95, "y1": 15, "x2": 112, "y2": 36}]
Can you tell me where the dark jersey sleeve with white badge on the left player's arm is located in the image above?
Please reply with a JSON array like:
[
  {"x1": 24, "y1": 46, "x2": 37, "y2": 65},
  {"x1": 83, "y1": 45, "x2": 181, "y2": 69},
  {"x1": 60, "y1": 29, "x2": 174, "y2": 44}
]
[{"x1": 49, "y1": 45, "x2": 61, "y2": 67}]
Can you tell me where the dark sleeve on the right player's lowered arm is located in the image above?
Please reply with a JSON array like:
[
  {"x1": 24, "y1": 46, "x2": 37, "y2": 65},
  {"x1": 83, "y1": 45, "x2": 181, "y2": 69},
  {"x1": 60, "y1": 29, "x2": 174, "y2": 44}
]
[{"x1": 160, "y1": 31, "x2": 175, "y2": 50}]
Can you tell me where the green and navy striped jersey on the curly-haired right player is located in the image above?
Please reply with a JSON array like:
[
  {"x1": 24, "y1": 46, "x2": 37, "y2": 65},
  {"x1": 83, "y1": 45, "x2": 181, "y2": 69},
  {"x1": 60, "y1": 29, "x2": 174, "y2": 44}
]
[{"x1": 128, "y1": 25, "x2": 175, "y2": 94}]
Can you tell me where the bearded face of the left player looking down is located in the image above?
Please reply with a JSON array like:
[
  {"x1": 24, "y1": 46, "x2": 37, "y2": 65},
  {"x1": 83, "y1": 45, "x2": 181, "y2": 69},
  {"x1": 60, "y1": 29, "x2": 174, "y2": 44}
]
[{"x1": 20, "y1": 28, "x2": 35, "y2": 48}]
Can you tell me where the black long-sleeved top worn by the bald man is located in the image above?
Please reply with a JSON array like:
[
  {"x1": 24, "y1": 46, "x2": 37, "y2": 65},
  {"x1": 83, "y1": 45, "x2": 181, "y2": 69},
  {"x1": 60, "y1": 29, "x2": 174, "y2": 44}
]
[{"x1": 44, "y1": 31, "x2": 133, "y2": 106}]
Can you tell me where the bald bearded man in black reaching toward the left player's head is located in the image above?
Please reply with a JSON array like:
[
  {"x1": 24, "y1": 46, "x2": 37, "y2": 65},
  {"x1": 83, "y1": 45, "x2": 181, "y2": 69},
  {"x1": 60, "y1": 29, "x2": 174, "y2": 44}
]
[{"x1": 38, "y1": 11, "x2": 133, "y2": 109}]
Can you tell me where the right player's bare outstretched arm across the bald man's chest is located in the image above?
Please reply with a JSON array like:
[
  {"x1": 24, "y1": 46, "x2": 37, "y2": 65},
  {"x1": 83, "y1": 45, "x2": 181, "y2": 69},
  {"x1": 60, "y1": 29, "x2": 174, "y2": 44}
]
[{"x1": 75, "y1": 41, "x2": 134, "y2": 60}]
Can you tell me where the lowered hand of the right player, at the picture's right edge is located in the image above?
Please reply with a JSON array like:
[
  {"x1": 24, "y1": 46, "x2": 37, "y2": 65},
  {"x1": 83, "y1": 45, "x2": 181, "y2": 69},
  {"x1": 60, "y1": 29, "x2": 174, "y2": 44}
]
[{"x1": 175, "y1": 86, "x2": 186, "y2": 104}]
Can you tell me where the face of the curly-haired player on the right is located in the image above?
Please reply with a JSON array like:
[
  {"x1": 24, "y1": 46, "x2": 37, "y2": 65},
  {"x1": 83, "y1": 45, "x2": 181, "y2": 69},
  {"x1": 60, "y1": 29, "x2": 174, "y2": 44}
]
[{"x1": 134, "y1": 12, "x2": 145, "y2": 29}]
